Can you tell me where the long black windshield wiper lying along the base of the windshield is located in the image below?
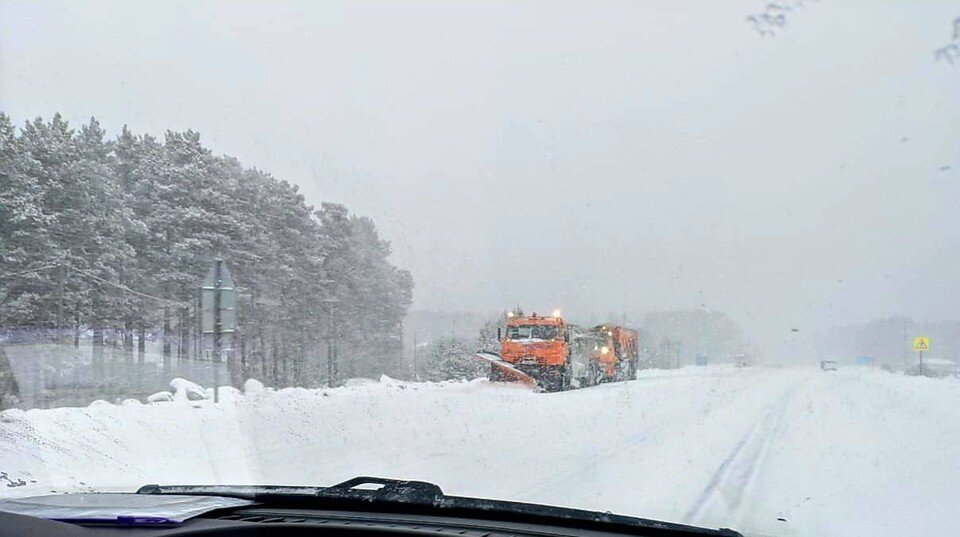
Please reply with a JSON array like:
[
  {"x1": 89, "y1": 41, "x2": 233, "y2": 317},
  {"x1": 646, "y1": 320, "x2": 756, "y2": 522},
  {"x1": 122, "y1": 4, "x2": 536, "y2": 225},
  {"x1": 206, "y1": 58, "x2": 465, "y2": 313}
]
[{"x1": 137, "y1": 476, "x2": 740, "y2": 537}]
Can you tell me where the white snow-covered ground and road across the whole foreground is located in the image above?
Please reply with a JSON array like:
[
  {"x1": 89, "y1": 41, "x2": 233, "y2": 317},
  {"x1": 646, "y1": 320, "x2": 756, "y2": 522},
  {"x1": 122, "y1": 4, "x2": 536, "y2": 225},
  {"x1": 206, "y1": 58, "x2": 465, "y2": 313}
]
[{"x1": 0, "y1": 366, "x2": 960, "y2": 535}]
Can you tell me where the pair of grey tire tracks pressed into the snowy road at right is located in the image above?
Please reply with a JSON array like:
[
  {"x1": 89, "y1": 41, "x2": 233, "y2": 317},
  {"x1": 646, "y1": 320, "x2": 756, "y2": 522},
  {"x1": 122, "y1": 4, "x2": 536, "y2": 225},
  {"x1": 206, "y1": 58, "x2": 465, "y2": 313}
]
[{"x1": 684, "y1": 386, "x2": 796, "y2": 524}]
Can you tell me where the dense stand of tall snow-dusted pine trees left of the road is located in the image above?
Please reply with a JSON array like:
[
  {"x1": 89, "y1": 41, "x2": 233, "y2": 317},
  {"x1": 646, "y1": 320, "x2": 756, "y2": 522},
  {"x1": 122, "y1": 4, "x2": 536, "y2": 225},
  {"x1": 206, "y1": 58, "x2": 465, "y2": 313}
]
[{"x1": 0, "y1": 115, "x2": 413, "y2": 392}]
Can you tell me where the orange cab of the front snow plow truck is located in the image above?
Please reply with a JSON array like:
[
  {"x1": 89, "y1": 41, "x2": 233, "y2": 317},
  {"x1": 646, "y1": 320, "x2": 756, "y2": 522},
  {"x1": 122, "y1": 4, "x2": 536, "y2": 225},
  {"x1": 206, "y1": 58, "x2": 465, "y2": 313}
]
[{"x1": 500, "y1": 316, "x2": 569, "y2": 367}]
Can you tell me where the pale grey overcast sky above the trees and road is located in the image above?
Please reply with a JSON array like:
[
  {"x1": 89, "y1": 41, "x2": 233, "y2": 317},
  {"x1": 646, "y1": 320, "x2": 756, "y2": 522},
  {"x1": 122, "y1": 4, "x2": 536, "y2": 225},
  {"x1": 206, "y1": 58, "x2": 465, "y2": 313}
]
[{"x1": 0, "y1": 0, "x2": 960, "y2": 360}]
